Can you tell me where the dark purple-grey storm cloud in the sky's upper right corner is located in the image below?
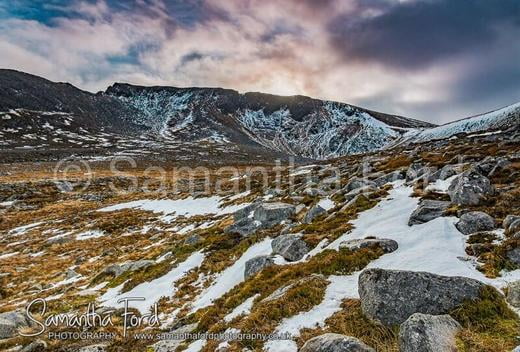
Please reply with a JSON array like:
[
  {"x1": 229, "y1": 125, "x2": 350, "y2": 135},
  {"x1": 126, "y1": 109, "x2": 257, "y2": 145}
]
[{"x1": 328, "y1": 0, "x2": 520, "y2": 70}]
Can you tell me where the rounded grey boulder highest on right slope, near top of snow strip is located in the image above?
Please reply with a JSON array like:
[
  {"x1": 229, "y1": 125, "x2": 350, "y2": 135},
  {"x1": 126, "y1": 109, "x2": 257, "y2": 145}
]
[{"x1": 448, "y1": 170, "x2": 494, "y2": 205}]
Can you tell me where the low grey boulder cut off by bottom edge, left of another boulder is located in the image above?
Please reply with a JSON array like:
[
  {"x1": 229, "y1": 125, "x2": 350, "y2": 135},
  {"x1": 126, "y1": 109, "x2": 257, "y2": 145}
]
[{"x1": 300, "y1": 333, "x2": 375, "y2": 352}]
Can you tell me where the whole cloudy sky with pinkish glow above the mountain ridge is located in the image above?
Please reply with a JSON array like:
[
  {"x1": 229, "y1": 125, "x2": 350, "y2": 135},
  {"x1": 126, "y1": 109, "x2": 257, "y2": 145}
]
[{"x1": 0, "y1": 0, "x2": 520, "y2": 124}]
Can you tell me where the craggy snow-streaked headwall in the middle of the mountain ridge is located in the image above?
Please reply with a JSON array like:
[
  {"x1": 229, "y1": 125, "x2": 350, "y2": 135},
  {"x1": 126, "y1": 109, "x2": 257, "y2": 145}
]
[{"x1": 104, "y1": 83, "x2": 431, "y2": 159}]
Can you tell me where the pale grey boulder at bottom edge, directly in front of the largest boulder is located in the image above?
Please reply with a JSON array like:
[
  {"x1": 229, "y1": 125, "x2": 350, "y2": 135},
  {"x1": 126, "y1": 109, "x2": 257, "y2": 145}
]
[{"x1": 399, "y1": 313, "x2": 461, "y2": 352}]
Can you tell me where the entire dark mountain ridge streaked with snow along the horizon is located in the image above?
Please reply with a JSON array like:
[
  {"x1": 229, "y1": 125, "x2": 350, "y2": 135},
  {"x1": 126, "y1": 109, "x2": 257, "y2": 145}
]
[{"x1": 0, "y1": 70, "x2": 520, "y2": 160}]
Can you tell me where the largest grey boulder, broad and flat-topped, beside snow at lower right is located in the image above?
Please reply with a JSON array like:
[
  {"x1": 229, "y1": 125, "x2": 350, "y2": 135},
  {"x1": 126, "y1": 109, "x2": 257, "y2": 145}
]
[{"x1": 358, "y1": 269, "x2": 484, "y2": 325}]
